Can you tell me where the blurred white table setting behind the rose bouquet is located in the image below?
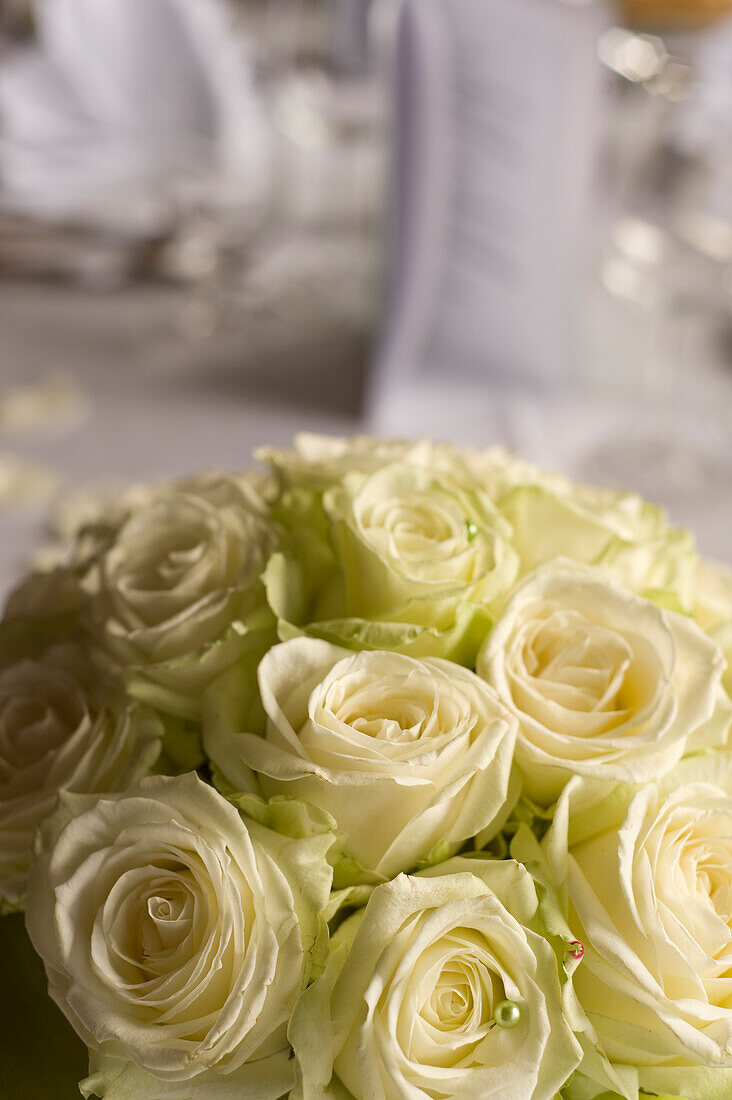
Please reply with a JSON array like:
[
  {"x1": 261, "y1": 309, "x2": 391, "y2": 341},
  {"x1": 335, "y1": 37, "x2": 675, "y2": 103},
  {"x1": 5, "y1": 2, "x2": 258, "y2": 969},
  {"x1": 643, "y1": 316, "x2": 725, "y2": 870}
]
[{"x1": 0, "y1": 0, "x2": 732, "y2": 589}]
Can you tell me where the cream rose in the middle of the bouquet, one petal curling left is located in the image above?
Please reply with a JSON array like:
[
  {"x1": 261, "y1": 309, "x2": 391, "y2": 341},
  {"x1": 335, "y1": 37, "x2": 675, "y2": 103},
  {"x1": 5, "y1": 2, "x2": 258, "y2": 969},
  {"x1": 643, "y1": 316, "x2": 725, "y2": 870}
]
[{"x1": 204, "y1": 638, "x2": 515, "y2": 881}]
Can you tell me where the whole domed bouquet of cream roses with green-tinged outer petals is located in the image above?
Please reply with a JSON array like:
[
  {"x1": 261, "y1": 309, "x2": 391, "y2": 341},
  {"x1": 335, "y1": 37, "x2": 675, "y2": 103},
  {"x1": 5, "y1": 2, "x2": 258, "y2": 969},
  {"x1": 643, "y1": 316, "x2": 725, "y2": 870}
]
[{"x1": 0, "y1": 436, "x2": 732, "y2": 1100}]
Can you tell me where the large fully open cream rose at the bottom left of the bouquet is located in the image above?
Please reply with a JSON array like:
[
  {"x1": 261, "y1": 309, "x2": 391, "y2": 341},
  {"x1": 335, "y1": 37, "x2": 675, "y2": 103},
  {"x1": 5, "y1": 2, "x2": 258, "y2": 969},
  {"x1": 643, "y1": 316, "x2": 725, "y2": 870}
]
[{"x1": 26, "y1": 773, "x2": 330, "y2": 1100}]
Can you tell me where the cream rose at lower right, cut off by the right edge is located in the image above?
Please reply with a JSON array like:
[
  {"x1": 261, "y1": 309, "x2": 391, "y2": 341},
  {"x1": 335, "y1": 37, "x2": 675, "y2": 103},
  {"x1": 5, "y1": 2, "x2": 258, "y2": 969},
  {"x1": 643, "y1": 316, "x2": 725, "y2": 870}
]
[{"x1": 546, "y1": 752, "x2": 732, "y2": 1100}]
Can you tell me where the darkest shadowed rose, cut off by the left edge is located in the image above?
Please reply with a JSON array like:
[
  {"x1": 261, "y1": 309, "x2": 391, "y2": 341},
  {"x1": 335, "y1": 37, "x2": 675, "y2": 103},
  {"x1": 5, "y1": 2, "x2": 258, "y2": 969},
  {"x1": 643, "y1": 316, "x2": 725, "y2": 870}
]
[{"x1": 0, "y1": 645, "x2": 163, "y2": 908}]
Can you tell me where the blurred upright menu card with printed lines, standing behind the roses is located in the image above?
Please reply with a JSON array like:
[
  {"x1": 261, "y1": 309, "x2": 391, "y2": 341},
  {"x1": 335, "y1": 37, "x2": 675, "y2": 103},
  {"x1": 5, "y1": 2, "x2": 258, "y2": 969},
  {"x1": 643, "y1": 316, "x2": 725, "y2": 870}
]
[{"x1": 378, "y1": 0, "x2": 610, "y2": 399}]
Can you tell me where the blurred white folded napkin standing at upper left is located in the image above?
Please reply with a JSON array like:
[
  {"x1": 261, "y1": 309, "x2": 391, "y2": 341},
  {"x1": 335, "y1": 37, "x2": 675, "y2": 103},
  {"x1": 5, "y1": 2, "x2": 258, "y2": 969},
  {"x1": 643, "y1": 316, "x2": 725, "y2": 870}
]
[{"x1": 0, "y1": 0, "x2": 269, "y2": 234}]
